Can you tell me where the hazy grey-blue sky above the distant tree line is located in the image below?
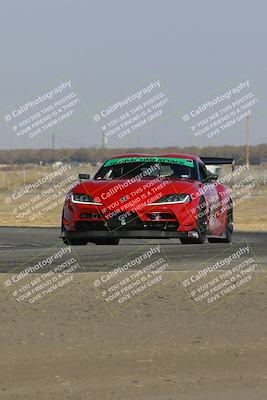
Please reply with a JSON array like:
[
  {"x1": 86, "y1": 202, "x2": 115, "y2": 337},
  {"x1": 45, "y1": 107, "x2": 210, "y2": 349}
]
[{"x1": 0, "y1": 0, "x2": 267, "y2": 149}]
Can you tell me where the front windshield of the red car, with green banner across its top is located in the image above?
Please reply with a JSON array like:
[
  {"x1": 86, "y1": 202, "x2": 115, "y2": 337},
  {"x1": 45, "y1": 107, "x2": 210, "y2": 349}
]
[{"x1": 94, "y1": 157, "x2": 195, "y2": 180}]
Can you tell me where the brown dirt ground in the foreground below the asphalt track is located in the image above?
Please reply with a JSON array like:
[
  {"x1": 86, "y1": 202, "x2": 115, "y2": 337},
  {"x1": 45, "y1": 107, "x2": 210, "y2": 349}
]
[{"x1": 0, "y1": 272, "x2": 267, "y2": 400}]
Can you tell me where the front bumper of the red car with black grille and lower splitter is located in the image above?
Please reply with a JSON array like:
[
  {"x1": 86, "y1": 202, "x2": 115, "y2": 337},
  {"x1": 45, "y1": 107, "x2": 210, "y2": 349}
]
[{"x1": 61, "y1": 206, "x2": 199, "y2": 241}]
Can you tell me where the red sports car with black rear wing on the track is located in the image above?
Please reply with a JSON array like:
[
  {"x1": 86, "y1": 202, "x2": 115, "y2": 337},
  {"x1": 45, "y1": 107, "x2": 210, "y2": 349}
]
[{"x1": 61, "y1": 154, "x2": 234, "y2": 245}]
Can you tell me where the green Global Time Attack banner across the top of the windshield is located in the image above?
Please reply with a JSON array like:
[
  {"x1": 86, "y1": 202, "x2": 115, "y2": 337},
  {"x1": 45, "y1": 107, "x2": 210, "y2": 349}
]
[{"x1": 104, "y1": 157, "x2": 194, "y2": 168}]
